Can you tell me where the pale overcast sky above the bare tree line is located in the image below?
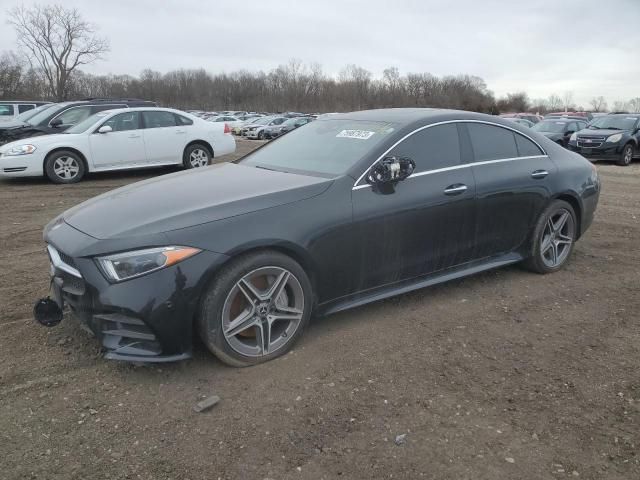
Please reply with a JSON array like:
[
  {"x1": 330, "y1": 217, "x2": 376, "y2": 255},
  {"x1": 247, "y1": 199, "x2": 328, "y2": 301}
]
[{"x1": 0, "y1": 0, "x2": 640, "y2": 106}]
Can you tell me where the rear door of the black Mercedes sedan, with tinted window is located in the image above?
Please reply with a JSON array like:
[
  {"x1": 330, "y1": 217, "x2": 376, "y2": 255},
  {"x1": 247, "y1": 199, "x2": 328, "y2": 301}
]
[{"x1": 465, "y1": 122, "x2": 557, "y2": 258}]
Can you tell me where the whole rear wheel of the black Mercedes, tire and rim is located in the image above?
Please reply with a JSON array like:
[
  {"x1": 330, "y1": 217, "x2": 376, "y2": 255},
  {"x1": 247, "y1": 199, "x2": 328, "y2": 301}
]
[{"x1": 525, "y1": 200, "x2": 577, "y2": 273}]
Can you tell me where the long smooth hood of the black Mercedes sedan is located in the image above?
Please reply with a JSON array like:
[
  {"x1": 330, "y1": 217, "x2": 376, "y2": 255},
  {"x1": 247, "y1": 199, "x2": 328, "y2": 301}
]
[{"x1": 63, "y1": 163, "x2": 332, "y2": 239}]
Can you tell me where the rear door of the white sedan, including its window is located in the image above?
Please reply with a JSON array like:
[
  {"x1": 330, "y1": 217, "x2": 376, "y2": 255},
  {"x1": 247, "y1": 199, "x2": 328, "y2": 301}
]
[{"x1": 142, "y1": 110, "x2": 181, "y2": 165}]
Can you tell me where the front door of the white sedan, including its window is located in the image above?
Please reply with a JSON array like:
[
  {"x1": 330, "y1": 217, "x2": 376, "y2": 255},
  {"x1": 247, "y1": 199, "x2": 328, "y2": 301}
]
[{"x1": 89, "y1": 111, "x2": 147, "y2": 169}]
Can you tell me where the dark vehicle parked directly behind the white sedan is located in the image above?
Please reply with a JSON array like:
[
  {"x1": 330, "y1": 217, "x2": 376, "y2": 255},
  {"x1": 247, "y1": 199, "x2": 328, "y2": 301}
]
[{"x1": 0, "y1": 98, "x2": 156, "y2": 145}]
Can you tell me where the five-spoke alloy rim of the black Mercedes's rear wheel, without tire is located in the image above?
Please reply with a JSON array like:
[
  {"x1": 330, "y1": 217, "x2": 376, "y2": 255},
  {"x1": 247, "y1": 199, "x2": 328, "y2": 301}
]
[{"x1": 540, "y1": 208, "x2": 575, "y2": 268}]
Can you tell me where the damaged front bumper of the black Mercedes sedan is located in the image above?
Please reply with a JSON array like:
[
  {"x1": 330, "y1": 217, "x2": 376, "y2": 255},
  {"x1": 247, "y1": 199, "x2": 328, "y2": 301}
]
[{"x1": 45, "y1": 224, "x2": 226, "y2": 362}]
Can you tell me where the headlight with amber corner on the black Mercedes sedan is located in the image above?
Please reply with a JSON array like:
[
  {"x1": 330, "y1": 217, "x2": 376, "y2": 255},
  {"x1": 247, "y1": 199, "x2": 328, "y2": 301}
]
[{"x1": 96, "y1": 247, "x2": 200, "y2": 282}]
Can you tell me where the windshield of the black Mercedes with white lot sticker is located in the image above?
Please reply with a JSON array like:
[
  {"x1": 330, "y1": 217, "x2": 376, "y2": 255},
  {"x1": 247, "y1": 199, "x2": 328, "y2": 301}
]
[{"x1": 239, "y1": 120, "x2": 394, "y2": 177}]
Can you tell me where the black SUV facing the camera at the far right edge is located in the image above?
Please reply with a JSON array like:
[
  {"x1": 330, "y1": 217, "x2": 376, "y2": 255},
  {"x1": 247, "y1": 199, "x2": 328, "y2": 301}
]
[{"x1": 569, "y1": 113, "x2": 640, "y2": 166}]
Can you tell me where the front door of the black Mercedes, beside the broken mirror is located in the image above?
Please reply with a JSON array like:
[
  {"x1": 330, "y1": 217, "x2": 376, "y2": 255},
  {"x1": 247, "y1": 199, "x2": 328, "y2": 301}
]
[{"x1": 352, "y1": 124, "x2": 476, "y2": 290}]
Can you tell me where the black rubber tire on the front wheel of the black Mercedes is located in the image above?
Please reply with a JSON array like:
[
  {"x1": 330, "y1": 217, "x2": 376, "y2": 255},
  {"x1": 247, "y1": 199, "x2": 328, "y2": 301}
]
[{"x1": 196, "y1": 250, "x2": 313, "y2": 367}]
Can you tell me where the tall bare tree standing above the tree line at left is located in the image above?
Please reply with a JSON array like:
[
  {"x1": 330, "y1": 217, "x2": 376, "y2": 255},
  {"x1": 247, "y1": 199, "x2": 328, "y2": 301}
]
[{"x1": 8, "y1": 5, "x2": 109, "y2": 101}]
